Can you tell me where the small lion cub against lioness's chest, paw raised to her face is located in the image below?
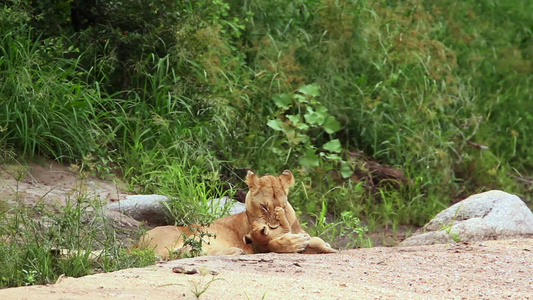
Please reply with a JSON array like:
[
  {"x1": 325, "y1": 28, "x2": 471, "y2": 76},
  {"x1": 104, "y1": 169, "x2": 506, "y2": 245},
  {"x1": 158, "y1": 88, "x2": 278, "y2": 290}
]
[{"x1": 244, "y1": 207, "x2": 338, "y2": 254}]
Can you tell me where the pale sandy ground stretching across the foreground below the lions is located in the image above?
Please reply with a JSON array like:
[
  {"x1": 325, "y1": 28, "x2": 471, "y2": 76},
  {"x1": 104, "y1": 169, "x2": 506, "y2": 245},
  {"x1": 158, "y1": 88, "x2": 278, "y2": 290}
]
[{"x1": 0, "y1": 239, "x2": 533, "y2": 300}]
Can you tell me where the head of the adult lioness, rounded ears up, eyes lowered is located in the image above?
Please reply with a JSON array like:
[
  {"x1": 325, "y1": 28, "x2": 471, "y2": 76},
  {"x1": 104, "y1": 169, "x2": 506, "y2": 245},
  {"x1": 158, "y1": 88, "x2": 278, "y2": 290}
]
[{"x1": 246, "y1": 170, "x2": 294, "y2": 229}]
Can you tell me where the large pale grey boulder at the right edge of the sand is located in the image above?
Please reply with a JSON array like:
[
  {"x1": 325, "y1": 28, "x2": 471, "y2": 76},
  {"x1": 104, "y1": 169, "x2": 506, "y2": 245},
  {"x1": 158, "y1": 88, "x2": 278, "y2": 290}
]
[{"x1": 400, "y1": 190, "x2": 533, "y2": 246}]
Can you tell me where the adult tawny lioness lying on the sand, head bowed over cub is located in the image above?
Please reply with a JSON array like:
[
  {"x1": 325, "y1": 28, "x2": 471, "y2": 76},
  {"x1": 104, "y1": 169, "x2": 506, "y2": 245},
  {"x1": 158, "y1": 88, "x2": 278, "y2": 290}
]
[{"x1": 137, "y1": 170, "x2": 336, "y2": 259}]
